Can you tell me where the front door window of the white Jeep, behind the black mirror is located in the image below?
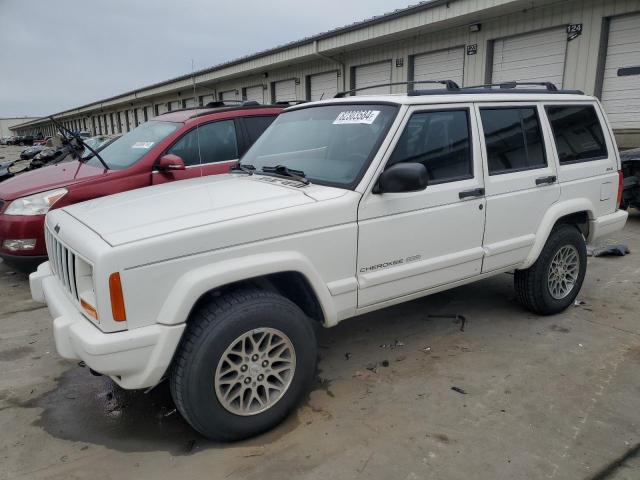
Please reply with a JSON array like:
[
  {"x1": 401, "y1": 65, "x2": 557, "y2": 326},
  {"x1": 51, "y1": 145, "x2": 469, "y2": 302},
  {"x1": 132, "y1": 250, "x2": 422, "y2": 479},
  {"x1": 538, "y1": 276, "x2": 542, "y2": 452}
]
[{"x1": 387, "y1": 110, "x2": 473, "y2": 183}]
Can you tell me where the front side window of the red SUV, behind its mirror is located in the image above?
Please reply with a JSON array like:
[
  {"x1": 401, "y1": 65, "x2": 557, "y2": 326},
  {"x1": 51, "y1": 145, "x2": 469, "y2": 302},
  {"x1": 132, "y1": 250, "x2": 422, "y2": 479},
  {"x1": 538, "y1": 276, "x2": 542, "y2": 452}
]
[{"x1": 167, "y1": 120, "x2": 238, "y2": 165}]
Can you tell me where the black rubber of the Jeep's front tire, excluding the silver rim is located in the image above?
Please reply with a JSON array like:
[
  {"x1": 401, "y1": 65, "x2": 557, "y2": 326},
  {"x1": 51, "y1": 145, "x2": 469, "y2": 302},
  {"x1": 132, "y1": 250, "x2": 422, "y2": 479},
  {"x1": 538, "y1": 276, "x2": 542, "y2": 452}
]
[{"x1": 170, "y1": 289, "x2": 317, "y2": 441}]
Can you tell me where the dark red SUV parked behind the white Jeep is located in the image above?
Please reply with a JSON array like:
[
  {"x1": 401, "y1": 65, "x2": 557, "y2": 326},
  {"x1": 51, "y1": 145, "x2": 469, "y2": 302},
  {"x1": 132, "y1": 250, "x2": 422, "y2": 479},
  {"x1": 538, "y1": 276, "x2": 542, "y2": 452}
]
[{"x1": 0, "y1": 105, "x2": 283, "y2": 271}]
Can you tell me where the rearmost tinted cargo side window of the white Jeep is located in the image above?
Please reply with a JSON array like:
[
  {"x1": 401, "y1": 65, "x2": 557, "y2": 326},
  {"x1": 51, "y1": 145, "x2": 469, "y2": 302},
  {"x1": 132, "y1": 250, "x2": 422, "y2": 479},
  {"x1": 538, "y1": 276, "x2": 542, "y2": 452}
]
[{"x1": 546, "y1": 105, "x2": 607, "y2": 164}]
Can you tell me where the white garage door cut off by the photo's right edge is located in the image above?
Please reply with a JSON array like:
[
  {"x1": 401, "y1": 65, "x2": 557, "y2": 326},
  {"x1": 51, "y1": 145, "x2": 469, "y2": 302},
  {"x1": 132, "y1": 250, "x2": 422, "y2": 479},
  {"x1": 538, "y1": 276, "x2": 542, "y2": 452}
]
[{"x1": 602, "y1": 15, "x2": 640, "y2": 129}]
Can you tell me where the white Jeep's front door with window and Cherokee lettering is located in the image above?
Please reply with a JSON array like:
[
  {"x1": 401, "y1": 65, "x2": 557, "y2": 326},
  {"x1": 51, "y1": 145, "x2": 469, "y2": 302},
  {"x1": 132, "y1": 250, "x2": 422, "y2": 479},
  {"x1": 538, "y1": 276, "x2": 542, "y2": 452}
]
[{"x1": 357, "y1": 104, "x2": 485, "y2": 308}]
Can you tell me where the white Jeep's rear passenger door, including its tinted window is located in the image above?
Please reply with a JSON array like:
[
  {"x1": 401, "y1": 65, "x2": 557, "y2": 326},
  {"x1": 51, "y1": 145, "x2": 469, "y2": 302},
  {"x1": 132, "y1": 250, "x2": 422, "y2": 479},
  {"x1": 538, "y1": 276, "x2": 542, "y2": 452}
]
[{"x1": 476, "y1": 103, "x2": 560, "y2": 272}]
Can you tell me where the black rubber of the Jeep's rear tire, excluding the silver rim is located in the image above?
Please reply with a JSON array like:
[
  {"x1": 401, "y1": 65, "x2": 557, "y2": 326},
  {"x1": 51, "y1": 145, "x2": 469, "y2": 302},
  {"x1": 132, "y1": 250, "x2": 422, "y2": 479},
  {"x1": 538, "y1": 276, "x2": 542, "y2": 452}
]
[{"x1": 514, "y1": 225, "x2": 587, "y2": 315}]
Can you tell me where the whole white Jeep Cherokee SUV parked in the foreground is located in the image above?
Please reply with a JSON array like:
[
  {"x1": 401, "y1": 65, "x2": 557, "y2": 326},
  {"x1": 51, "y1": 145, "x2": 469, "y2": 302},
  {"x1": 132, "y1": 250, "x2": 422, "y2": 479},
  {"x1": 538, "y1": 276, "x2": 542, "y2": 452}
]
[{"x1": 31, "y1": 85, "x2": 627, "y2": 440}]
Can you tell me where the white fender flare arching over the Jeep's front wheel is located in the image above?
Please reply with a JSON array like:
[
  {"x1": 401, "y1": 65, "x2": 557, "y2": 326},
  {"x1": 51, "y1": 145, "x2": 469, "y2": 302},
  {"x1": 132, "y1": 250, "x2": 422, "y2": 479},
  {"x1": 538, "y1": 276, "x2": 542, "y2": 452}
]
[{"x1": 157, "y1": 251, "x2": 337, "y2": 325}]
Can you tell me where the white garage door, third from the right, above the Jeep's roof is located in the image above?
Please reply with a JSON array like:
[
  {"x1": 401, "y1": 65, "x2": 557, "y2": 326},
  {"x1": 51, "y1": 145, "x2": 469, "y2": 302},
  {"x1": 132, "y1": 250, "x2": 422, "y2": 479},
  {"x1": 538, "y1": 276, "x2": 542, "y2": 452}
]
[{"x1": 413, "y1": 47, "x2": 464, "y2": 90}]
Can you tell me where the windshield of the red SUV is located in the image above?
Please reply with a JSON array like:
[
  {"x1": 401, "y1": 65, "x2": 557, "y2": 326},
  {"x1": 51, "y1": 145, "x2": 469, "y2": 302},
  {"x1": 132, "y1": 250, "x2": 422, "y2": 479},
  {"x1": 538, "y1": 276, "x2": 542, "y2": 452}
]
[{"x1": 87, "y1": 121, "x2": 182, "y2": 170}]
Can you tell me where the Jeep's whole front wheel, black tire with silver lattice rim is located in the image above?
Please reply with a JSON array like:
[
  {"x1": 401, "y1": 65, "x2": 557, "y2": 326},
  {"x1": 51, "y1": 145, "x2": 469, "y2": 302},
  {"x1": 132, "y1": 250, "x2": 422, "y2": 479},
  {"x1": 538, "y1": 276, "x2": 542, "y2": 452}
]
[{"x1": 170, "y1": 290, "x2": 317, "y2": 441}]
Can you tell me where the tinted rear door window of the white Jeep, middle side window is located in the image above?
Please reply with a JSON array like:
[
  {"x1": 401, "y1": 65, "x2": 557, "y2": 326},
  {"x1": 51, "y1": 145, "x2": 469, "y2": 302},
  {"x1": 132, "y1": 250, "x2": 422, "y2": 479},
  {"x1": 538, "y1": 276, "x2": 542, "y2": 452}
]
[{"x1": 480, "y1": 107, "x2": 547, "y2": 175}]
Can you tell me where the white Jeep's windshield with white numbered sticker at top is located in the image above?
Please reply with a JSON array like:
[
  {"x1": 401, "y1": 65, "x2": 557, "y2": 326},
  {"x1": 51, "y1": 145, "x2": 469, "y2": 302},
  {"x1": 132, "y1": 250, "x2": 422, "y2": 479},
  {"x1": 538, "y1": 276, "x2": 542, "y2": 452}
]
[{"x1": 242, "y1": 104, "x2": 397, "y2": 188}]
